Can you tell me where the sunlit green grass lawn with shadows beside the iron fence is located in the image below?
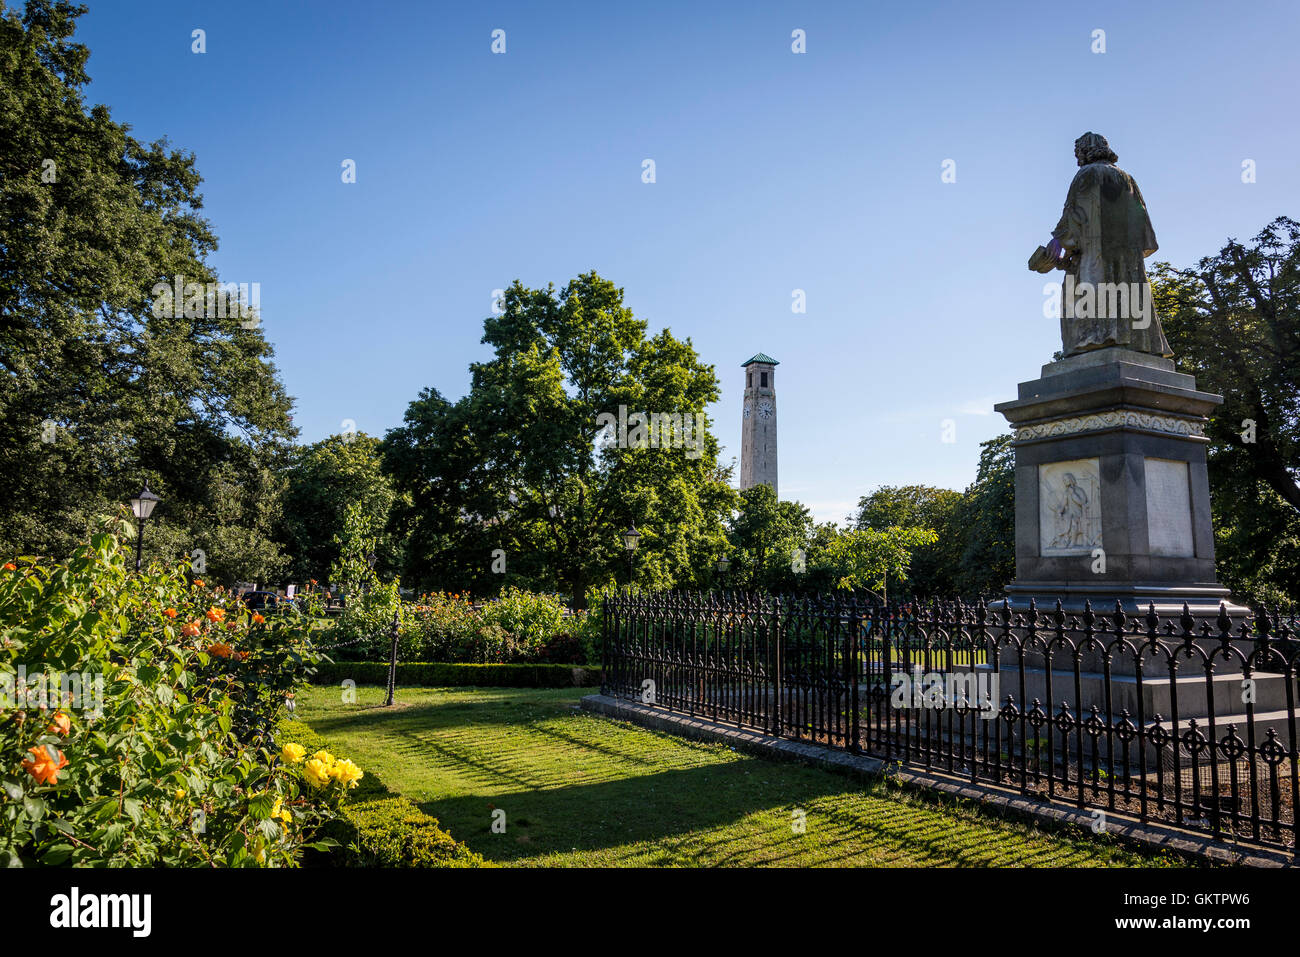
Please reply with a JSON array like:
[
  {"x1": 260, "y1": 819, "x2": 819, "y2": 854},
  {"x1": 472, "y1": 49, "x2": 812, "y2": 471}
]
[{"x1": 298, "y1": 688, "x2": 1178, "y2": 867}]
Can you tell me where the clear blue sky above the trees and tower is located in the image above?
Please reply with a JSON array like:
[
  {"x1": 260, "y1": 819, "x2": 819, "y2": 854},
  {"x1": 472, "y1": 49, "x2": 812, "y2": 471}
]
[{"x1": 78, "y1": 0, "x2": 1300, "y2": 520}]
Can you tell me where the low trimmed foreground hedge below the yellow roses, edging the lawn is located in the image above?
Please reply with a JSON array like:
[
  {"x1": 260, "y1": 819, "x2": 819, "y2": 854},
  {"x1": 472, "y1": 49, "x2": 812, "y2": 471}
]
[{"x1": 277, "y1": 719, "x2": 488, "y2": 867}]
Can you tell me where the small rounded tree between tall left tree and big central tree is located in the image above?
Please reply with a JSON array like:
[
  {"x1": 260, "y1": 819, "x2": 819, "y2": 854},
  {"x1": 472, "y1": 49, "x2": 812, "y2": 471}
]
[{"x1": 283, "y1": 433, "x2": 399, "y2": 581}]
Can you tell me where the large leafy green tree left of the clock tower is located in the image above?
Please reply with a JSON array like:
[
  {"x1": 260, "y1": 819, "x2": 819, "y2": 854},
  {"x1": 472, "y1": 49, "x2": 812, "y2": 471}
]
[{"x1": 384, "y1": 272, "x2": 735, "y2": 606}]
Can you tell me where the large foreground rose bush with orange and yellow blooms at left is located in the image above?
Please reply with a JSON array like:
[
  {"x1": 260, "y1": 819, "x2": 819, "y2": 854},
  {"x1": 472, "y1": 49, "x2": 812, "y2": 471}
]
[{"x1": 0, "y1": 523, "x2": 359, "y2": 866}]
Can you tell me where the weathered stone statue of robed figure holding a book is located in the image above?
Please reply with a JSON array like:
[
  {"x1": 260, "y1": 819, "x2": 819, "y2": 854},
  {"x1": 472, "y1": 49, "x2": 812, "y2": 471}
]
[{"x1": 1030, "y1": 133, "x2": 1173, "y2": 356}]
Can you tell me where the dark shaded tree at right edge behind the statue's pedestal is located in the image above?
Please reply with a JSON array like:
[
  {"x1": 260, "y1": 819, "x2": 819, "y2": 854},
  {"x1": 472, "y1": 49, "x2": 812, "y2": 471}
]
[{"x1": 1152, "y1": 217, "x2": 1300, "y2": 603}]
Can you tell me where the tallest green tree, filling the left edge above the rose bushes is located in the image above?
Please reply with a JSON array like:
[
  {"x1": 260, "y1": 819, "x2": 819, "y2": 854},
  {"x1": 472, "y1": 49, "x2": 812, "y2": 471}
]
[{"x1": 0, "y1": 0, "x2": 295, "y2": 580}]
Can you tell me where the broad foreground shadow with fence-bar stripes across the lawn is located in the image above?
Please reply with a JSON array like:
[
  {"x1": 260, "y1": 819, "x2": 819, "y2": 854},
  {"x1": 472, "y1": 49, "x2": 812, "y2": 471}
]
[{"x1": 419, "y1": 757, "x2": 1089, "y2": 867}]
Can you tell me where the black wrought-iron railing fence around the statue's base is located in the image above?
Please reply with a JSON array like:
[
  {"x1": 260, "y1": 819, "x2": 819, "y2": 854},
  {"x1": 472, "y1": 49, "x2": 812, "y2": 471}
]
[{"x1": 602, "y1": 592, "x2": 1300, "y2": 848}]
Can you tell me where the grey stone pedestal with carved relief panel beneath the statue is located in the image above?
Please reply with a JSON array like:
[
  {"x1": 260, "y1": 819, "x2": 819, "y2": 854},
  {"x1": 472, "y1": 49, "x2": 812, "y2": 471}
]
[{"x1": 995, "y1": 347, "x2": 1245, "y2": 618}]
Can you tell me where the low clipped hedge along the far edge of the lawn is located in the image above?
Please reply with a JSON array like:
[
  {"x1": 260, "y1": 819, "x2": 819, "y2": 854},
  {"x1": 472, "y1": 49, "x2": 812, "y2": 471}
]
[{"x1": 311, "y1": 662, "x2": 601, "y2": 688}]
